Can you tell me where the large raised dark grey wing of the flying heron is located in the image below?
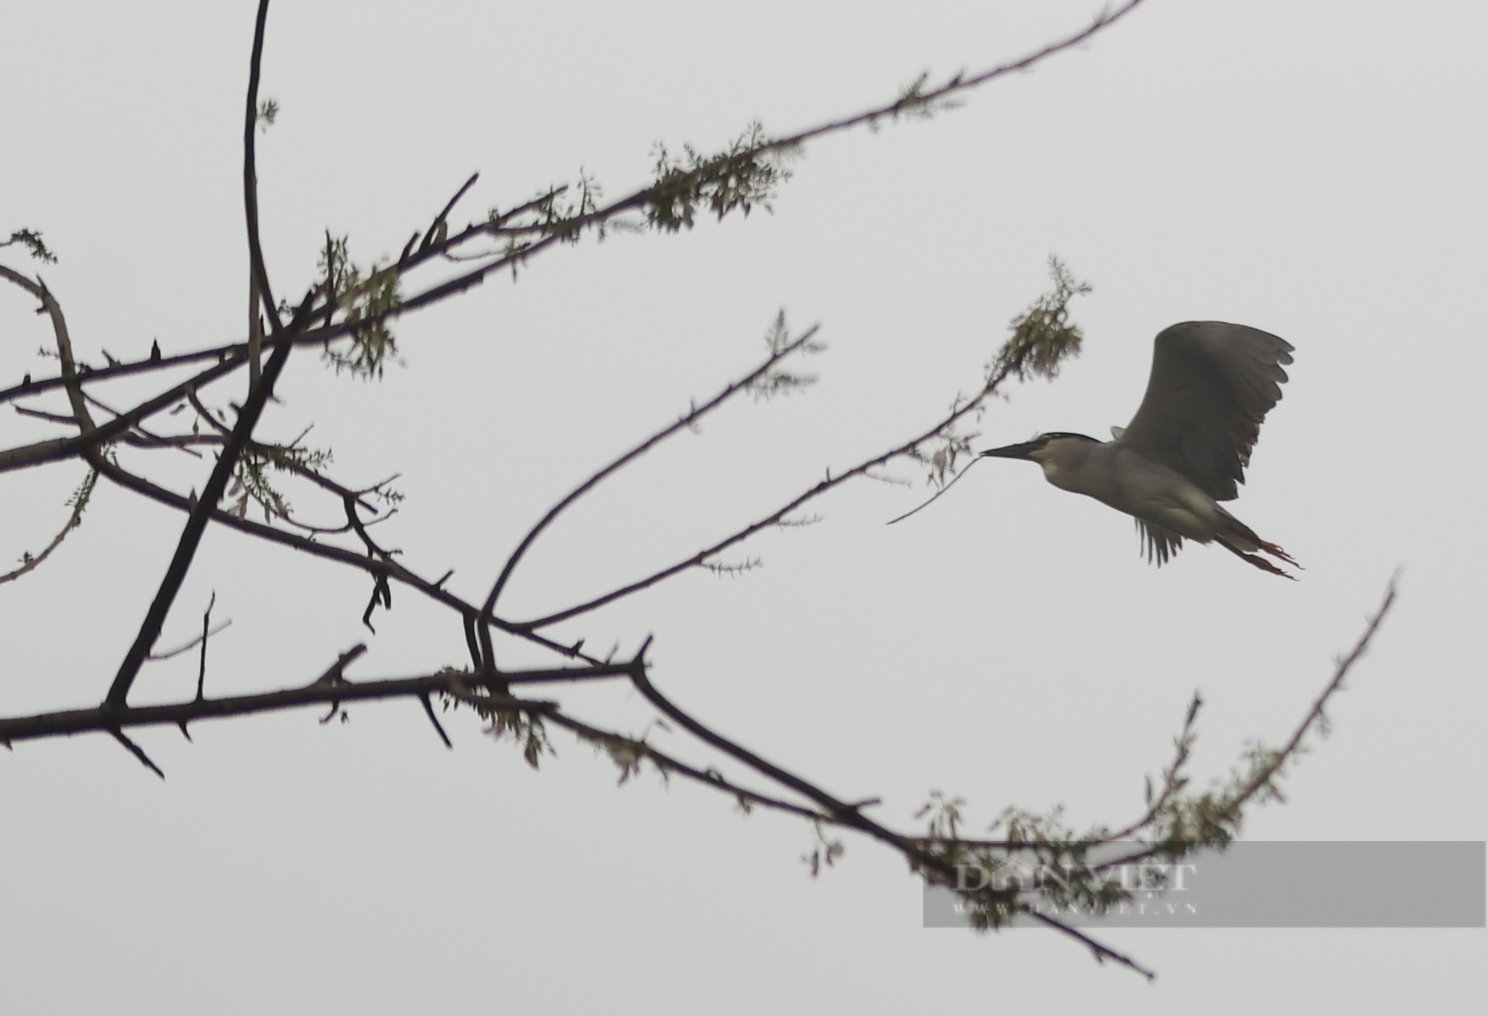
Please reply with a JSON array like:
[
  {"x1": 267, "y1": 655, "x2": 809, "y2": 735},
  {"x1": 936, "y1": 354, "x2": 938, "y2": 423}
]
[{"x1": 1113, "y1": 321, "x2": 1293, "y2": 499}]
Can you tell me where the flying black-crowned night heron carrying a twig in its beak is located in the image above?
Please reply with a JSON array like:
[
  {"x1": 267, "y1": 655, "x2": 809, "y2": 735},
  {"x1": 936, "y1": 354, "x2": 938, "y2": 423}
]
[{"x1": 981, "y1": 321, "x2": 1301, "y2": 579}]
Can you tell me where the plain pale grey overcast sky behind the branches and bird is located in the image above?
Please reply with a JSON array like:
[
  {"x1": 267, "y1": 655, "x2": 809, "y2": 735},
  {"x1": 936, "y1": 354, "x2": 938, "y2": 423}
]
[{"x1": 0, "y1": 0, "x2": 1488, "y2": 1013}]
